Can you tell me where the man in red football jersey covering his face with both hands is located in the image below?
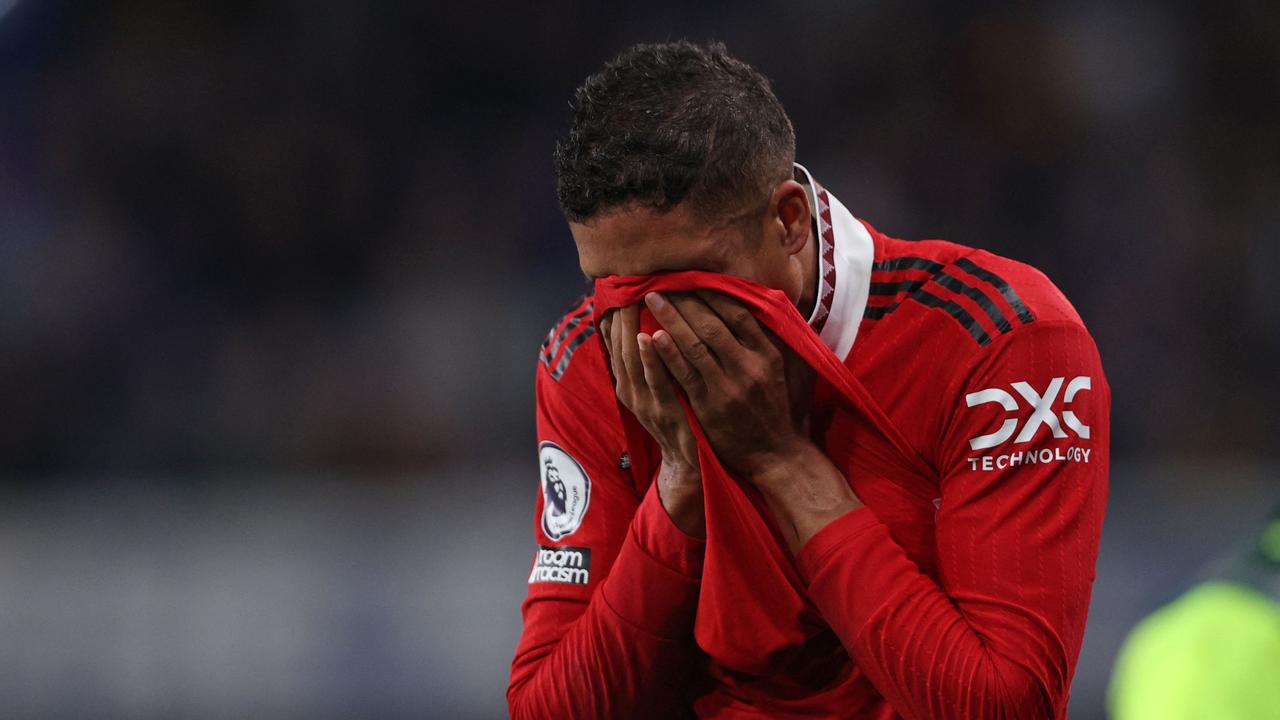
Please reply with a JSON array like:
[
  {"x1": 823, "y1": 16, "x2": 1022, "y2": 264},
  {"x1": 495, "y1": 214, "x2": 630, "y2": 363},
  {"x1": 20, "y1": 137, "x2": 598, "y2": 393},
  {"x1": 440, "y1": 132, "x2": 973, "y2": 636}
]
[{"x1": 508, "y1": 42, "x2": 1110, "y2": 717}]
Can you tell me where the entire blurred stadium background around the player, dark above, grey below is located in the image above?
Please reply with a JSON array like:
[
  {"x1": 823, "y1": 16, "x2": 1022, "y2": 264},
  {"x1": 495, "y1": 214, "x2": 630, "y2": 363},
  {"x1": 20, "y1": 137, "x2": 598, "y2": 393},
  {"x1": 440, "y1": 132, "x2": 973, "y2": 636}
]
[{"x1": 0, "y1": 0, "x2": 1280, "y2": 720}]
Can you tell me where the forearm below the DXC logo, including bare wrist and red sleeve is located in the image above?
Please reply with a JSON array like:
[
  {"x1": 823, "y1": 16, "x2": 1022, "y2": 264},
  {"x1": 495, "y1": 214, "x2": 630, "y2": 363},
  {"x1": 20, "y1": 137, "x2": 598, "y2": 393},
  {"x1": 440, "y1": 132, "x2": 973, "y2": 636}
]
[{"x1": 753, "y1": 446, "x2": 1069, "y2": 717}]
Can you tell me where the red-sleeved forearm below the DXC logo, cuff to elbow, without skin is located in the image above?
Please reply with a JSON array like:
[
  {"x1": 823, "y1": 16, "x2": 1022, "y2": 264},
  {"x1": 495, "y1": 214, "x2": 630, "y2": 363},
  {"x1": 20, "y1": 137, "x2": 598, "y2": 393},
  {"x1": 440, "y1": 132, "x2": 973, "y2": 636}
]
[{"x1": 797, "y1": 509, "x2": 1070, "y2": 719}]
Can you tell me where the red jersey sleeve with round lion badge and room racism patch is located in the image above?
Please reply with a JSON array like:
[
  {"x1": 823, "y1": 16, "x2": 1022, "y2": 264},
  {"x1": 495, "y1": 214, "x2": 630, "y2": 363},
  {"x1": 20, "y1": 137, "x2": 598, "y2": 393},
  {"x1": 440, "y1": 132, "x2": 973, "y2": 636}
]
[{"x1": 507, "y1": 320, "x2": 703, "y2": 717}]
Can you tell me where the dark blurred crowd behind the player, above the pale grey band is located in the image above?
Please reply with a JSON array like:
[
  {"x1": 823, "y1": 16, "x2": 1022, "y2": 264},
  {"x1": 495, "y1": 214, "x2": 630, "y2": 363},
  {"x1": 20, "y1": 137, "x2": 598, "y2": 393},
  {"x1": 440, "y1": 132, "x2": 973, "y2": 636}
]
[{"x1": 0, "y1": 0, "x2": 1280, "y2": 477}]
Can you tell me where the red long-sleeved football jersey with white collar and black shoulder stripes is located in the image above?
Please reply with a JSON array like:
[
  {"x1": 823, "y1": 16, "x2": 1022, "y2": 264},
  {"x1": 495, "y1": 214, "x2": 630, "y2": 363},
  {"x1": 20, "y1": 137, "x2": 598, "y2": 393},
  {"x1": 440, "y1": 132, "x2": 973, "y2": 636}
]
[{"x1": 508, "y1": 167, "x2": 1110, "y2": 717}]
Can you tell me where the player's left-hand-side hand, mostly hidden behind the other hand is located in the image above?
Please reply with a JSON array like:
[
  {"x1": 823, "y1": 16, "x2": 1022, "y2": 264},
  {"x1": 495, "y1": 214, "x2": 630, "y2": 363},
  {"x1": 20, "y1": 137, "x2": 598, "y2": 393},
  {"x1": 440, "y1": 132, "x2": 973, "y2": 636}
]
[{"x1": 600, "y1": 304, "x2": 707, "y2": 538}]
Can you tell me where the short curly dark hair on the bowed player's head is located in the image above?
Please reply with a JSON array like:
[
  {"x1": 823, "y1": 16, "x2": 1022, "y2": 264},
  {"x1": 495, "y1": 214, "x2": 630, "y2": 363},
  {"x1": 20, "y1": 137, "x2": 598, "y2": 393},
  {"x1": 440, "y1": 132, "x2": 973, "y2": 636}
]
[{"x1": 554, "y1": 41, "x2": 795, "y2": 222}]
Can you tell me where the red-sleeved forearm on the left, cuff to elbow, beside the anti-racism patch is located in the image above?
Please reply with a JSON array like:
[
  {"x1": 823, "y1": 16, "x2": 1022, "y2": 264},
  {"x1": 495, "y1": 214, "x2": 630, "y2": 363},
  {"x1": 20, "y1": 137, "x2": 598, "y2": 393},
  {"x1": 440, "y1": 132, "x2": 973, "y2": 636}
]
[{"x1": 507, "y1": 481, "x2": 701, "y2": 717}]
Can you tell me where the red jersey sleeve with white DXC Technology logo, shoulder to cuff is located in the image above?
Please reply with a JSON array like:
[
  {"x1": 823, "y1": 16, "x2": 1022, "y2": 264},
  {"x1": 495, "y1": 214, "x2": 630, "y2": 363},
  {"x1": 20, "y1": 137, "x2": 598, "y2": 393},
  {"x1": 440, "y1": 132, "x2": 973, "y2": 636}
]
[{"x1": 797, "y1": 320, "x2": 1110, "y2": 719}]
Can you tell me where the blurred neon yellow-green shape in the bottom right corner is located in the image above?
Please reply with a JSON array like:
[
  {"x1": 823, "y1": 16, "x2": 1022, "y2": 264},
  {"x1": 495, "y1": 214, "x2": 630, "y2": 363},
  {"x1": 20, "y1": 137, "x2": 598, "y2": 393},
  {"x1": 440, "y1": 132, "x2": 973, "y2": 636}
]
[{"x1": 1107, "y1": 509, "x2": 1280, "y2": 720}]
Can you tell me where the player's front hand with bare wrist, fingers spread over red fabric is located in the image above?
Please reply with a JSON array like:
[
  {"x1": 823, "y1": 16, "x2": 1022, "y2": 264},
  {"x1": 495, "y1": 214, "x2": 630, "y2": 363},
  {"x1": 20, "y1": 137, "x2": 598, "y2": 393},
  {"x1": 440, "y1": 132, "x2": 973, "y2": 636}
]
[{"x1": 645, "y1": 292, "x2": 861, "y2": 551}]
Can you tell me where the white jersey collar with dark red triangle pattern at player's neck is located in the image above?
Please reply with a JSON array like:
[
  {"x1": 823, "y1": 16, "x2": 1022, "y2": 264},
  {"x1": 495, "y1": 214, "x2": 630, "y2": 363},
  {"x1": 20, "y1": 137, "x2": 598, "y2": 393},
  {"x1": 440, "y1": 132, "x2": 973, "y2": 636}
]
[{"x1": 795, "y1": 163, "x2": 876, "y2": 360}]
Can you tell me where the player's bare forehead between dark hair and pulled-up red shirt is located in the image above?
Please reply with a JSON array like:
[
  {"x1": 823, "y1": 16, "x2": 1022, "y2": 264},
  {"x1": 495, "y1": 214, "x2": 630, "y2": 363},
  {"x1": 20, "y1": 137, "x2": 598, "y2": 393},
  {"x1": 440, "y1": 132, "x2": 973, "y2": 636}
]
[{"x1": 570, "y1": 206, "x2": 737, "y2": 278}]
